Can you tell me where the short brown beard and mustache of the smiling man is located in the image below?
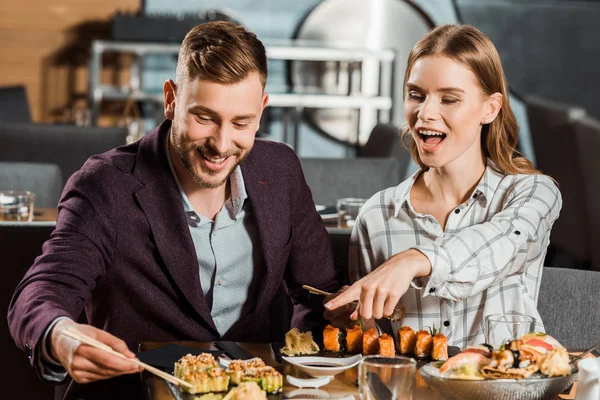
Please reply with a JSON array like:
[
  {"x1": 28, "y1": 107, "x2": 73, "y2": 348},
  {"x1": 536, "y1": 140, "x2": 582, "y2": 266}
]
[{"x1": 171, "y1": 124, "x2": 249, "y2": 189}]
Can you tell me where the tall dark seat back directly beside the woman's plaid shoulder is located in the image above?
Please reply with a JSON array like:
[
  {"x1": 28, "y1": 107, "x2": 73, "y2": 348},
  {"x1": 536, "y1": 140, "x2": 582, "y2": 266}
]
[{"x1": 526, "y1": 97, "x2": 591, "y2": 268}]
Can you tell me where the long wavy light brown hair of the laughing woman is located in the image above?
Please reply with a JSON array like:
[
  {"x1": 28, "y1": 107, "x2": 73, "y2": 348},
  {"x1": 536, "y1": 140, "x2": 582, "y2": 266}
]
[{"x1": 401, "y1": 25, "x2": 540, "y2": 175}]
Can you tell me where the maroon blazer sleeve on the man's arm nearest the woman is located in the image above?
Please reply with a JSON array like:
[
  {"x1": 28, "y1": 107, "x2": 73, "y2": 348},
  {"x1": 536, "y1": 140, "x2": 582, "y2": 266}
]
[{"x1": 286, "y1": 145, "x2": 341, "y2": 338}]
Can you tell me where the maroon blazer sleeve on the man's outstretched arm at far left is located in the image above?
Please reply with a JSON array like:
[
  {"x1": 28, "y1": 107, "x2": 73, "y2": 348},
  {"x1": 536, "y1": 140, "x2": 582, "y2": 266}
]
[{"x1": 8, "y1": 163, "x2": 116, "y2": 366}]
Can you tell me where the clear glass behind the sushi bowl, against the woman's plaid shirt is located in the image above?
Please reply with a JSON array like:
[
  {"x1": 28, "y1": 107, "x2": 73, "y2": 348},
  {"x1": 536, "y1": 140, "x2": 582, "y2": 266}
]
[{"x1": 485, "y1": 314, "x2": 535, "y2": 349}]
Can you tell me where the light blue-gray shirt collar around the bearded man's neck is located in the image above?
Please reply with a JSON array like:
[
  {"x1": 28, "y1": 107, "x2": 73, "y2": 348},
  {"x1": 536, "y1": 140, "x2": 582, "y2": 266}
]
[{"x1": 165, "y1": 130, "x2": 248, "y2": 223}]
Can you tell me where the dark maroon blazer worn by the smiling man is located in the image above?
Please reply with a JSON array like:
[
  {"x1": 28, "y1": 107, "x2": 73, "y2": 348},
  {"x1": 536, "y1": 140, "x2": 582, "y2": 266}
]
[{"x1": 8, "y1": 121, "x2": 339, "y2": 398}]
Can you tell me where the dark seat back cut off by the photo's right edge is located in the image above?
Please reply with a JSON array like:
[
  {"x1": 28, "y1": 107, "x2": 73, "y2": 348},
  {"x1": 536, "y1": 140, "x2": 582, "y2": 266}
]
[{"x1": 575, "y1": 117, "x2": 600, "y2": 272}]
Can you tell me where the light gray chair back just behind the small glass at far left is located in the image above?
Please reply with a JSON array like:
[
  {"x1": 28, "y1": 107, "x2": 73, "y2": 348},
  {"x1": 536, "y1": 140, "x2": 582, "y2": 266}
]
[{"x1": 0, "y1": 162, "x2": 63, "y2": 208}]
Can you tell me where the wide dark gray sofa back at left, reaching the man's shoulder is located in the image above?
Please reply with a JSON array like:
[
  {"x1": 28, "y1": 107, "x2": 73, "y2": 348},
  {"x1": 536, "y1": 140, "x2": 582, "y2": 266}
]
[{"x1": 0, "y1": 121, "x2": 127, "y2": 186}]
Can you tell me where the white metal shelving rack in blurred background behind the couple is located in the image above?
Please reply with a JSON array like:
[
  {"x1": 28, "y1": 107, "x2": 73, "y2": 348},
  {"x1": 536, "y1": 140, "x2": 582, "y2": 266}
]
[{"x1": 89, "y1": 40, "x2": 395, "y2": 147}]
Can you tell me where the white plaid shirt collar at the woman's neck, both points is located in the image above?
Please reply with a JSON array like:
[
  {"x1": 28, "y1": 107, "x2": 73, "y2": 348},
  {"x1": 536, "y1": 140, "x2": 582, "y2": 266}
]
[{"x1": 394, "y1": 159, "x2": 504, "y2": 217}]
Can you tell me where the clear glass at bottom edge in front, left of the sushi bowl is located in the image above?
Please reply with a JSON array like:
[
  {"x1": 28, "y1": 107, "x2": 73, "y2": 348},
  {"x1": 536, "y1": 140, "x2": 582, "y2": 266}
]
[{"x1": 358, "y1": 355, "x2": 417, "y2": 400}]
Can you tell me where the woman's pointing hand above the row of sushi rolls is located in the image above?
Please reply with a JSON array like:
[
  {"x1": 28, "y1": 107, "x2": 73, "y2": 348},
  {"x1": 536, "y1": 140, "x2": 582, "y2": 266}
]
[{"x1": 325, "y1": 249, "x2": 431, "y2": 320}]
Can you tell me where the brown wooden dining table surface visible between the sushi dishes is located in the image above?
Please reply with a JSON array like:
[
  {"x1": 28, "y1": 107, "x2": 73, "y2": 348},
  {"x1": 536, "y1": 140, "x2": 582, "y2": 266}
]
[{"x1": 139, "y1": 341, "x2": 577, "y2": 400}]
